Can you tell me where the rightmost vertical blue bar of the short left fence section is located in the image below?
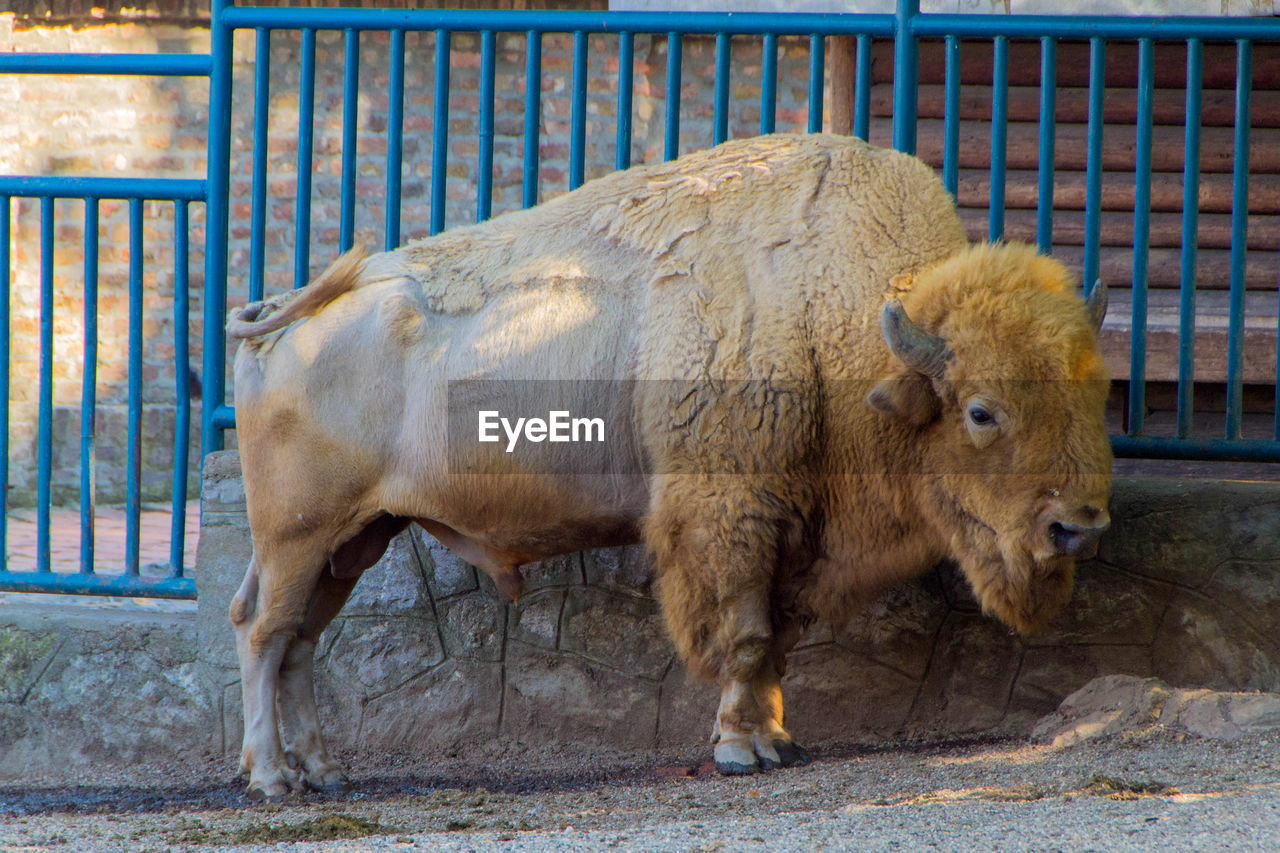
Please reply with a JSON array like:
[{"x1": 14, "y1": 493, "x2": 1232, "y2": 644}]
[{"x1": 171, "y1": 201, "x2": 191, "y2": 578}]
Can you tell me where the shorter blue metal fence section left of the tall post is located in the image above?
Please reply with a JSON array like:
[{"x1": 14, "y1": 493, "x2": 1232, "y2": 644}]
[{"x1": 0, "y1": 186, "x2": 206, "y2": 589}]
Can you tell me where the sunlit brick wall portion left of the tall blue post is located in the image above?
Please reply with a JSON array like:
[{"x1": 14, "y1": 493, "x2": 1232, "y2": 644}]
[{"x1": 0, "y1": 15, "x2": 209, "y2": 505}]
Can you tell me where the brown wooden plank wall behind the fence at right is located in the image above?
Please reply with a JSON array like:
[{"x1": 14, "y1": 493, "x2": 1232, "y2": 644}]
[{"x1": 832, "y1": 38, "x2": 1280, "y2": 384}]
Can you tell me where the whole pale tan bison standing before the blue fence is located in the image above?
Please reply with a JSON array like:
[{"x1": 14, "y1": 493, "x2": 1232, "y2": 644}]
[{"x1": 228, "y1": 136, "x2": 1111, "y2": 797}]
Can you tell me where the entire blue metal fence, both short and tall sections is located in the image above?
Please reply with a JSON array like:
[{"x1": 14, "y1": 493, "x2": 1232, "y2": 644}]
[{"x1": 0, "y1": 0, "x2": 1280, "y2": 597}]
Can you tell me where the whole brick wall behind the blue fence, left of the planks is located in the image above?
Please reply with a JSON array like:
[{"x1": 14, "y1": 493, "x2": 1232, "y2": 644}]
[{"x1": 0, "y1": 15, "x2": 824, "y2": 503}]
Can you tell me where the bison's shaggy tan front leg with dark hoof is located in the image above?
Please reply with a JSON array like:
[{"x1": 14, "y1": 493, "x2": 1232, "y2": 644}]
[{"x1": 645, "y1": 478, "x2": 809, "y2": 775}]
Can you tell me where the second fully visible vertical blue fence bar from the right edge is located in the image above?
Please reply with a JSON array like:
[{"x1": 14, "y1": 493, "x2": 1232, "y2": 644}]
[{"x1": 1178, "y1": 38, "x2": 1203, "y2": 438}]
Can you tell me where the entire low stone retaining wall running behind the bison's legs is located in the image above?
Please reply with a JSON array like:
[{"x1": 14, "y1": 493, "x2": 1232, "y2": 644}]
[{"x1": 0, "y1": 452, "x2": 1280, "y2": 781}]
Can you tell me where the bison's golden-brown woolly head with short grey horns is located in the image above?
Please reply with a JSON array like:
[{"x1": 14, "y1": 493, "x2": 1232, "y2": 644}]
[{"x1": 868, "y1": 245, "x2": 1111, "y2": 633}]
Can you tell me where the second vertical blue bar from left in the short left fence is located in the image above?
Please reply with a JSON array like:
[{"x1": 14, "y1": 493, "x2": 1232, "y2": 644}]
[{"x1": 37, "y1": 196, "x2": 54, "y2": 571}]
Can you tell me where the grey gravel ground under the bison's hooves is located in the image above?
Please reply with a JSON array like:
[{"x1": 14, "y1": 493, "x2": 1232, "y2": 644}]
[{"x1": 0, "y1": 734, "x2": 1280, "y2": 853}]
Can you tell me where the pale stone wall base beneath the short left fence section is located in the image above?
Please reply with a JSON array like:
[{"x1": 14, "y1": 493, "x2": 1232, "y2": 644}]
[{"x1": 0, "y1": 593, "x2": 206, "y2": 783}]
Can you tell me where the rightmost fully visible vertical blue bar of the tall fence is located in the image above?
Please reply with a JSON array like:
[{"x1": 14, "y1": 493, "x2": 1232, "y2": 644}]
[{"x1": 1226, "y1": 38, "x2": 1253, "y2": 438}]
